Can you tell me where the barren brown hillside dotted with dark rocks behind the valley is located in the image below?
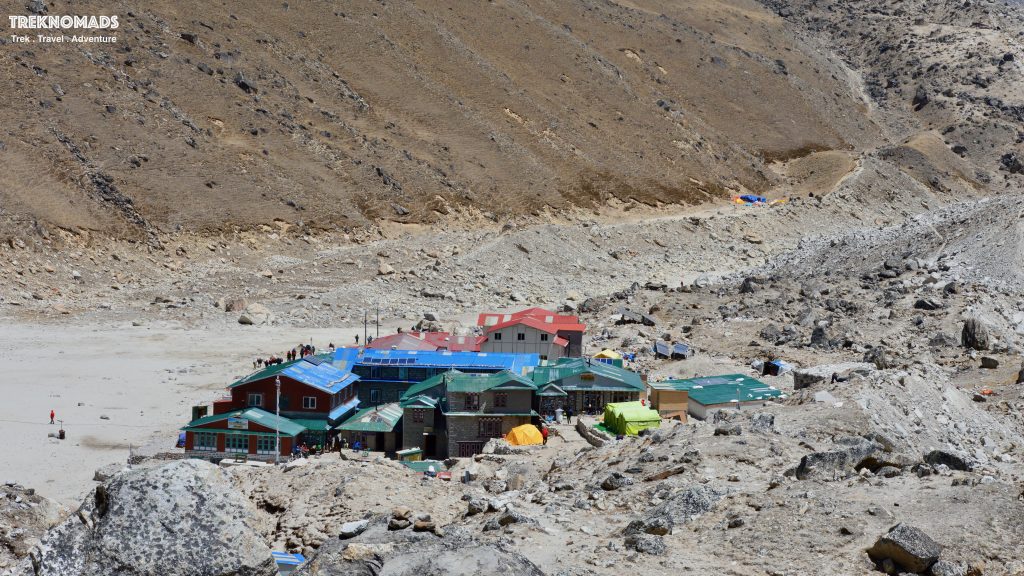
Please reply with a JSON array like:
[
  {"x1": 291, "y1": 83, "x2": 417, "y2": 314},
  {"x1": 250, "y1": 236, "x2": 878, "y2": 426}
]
[{"x1": 0, "y1": 0, "x2": 877, "y2": 238}]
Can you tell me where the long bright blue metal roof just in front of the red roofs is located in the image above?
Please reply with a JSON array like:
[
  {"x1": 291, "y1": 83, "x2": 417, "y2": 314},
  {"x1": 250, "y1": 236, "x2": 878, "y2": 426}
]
[{"x1": 334, "y1": 348, "x2": 541, "y2": 375}]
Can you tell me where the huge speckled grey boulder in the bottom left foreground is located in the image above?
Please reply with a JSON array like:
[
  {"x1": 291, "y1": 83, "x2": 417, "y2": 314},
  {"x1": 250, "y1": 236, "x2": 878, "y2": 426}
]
[{"x1": 22, "y1": 460, "x2": 278, "y2": 576}]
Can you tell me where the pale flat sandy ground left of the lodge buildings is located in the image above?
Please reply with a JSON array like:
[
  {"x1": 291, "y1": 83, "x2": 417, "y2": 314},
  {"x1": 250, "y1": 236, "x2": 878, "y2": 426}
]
[{"x1": 0, "y1": 319, "x2": 401, "y2": 505}]
